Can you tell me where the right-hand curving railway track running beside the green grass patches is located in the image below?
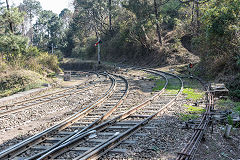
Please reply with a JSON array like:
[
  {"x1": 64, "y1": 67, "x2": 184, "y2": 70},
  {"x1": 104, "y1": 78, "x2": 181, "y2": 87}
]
[{"x1": 35, "y1": 70, "x2": 183, "y2": 160}]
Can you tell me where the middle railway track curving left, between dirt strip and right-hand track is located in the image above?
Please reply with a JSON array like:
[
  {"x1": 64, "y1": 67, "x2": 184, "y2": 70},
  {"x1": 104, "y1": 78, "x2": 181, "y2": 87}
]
[{"x1": 0, "y1": 74, "x2": 128, "y2": 159}]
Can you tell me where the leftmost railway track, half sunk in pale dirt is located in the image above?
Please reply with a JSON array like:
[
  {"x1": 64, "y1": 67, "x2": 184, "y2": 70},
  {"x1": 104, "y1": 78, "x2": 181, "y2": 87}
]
[{"x1": 0, "y1": 74, "x2": 98, "y2": 117}]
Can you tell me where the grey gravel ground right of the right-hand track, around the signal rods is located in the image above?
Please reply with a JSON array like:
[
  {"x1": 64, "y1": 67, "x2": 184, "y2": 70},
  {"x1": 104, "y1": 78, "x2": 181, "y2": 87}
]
[{"x1": 100, "y1": 67, "x2": 240, "y2": 160}]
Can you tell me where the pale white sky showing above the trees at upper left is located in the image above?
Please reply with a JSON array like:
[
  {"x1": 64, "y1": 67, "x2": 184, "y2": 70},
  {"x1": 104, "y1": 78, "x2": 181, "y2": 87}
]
[{"x1": 9, "y1": 0, "x2": 73, "y2": 14}]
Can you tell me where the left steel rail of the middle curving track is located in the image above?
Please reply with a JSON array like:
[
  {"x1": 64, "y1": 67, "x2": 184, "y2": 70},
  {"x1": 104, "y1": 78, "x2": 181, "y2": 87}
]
[{"x1": 0, "y1": 74, "x2": 115, "y2": 159}]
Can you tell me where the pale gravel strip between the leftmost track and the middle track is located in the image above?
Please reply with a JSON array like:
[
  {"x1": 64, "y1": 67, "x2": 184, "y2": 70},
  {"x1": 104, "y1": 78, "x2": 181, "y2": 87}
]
[{"x1": 0, "y1": 74, "x2": 107, "y2": 151}]
